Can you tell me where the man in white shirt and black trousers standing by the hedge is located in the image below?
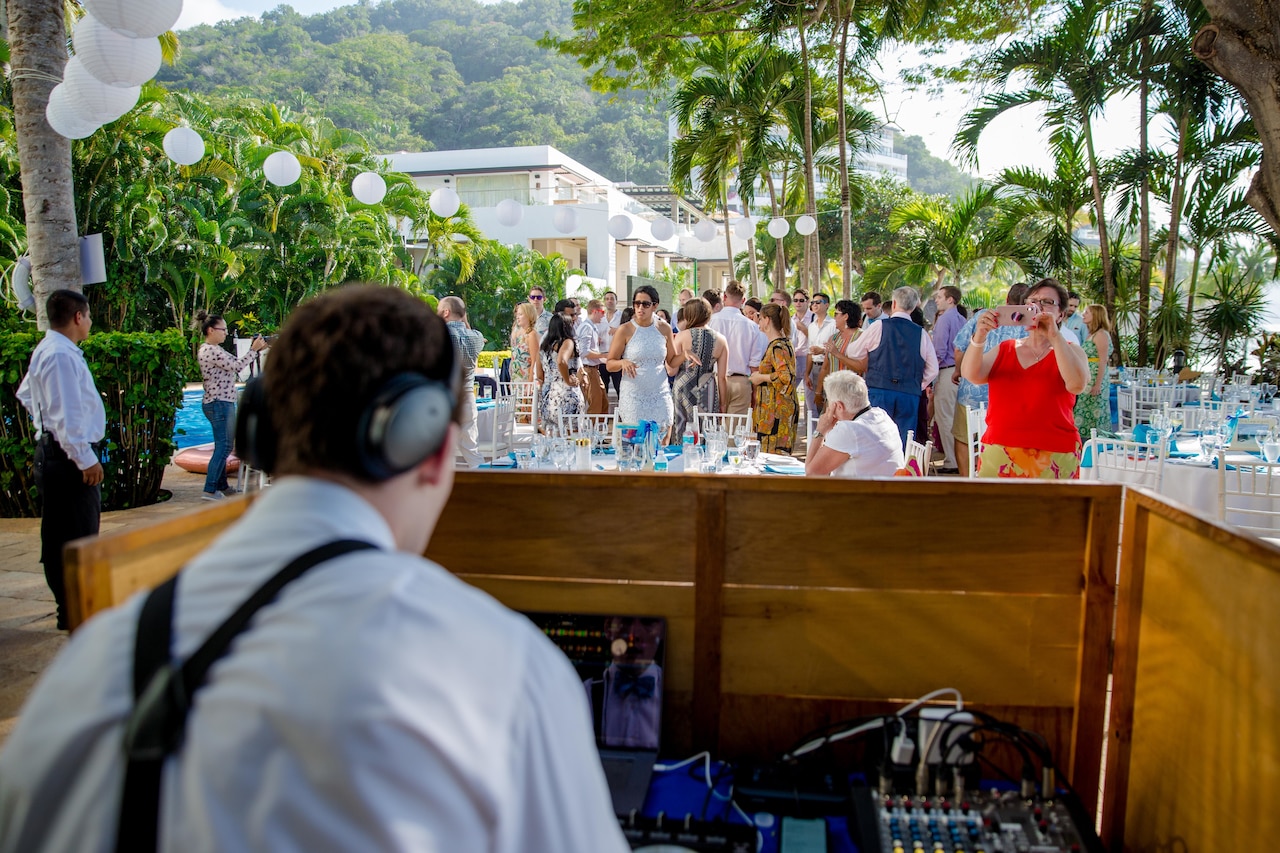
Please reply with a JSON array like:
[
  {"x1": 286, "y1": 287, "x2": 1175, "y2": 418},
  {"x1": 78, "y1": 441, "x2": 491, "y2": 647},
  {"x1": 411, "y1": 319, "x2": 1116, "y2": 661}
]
[{"x1": 18, "y1": 291, "x2": 106, "y2": 630}]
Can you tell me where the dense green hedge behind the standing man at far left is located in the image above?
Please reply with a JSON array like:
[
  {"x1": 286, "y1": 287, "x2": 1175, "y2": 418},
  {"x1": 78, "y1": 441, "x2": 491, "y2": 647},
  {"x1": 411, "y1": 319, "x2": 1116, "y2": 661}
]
[{"x1": 0, "y1": 329, "x2": 191, "y2": 517}]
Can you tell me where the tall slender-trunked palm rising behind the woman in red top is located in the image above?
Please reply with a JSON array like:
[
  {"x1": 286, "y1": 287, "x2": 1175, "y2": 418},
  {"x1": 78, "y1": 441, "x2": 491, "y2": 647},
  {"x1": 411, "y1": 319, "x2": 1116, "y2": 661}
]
[{"x1": 955, "y1": 0, "x2": 1116, "y2": 313}]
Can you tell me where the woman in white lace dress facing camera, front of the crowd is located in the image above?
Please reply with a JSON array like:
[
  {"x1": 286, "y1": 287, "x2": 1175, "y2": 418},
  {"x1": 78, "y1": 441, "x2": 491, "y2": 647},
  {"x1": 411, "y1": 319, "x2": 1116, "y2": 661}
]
[{"x1": 607, "y1": 284, "x2": 676, "y2": 435}]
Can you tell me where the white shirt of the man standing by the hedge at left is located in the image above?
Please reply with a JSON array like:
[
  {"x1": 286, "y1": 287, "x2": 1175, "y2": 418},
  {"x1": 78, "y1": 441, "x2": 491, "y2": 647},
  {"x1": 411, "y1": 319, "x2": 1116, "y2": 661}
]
[{"x1": 17, "y1": 329, "x2": 106, "y2": 471}]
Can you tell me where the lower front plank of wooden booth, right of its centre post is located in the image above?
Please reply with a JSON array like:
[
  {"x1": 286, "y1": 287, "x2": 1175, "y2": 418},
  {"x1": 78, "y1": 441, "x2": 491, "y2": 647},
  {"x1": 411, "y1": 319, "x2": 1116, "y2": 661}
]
[{"x1": 723, "y1": 587, "x2": 1080, "y2": 707}]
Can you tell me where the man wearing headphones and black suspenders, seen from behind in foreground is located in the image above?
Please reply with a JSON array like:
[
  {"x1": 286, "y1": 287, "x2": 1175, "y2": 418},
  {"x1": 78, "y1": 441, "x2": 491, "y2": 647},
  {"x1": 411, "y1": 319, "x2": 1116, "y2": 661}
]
[{"x1": 0, "y1": 286, "x2": 627, "y2": 853}]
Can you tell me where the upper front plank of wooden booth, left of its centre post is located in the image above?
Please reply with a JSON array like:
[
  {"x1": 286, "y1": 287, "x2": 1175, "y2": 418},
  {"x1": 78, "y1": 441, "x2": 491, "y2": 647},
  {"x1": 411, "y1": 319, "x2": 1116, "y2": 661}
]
[{"x1": 437, "y1": 474, "x2": 696, "y2": 583}]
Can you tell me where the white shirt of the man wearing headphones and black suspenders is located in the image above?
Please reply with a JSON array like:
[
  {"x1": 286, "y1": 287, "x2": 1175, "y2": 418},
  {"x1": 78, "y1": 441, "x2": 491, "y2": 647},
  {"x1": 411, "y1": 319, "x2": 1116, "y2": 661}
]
[{"x1": 0, "y1": 476, "x2": 627, "y2": 853}]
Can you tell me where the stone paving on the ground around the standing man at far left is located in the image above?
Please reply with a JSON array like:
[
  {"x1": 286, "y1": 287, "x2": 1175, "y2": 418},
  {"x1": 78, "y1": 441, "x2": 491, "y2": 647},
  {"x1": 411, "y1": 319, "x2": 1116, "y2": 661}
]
[{"x1": 0, "y1": 465, "x2": 212, "y2": 745}]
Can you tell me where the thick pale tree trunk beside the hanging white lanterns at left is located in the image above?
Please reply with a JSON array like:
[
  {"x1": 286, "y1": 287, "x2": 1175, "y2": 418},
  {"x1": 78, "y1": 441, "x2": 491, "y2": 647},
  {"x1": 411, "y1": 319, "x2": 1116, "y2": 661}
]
[{"x1": 8, "y1": 0, "x2": 81, "y2": 329}]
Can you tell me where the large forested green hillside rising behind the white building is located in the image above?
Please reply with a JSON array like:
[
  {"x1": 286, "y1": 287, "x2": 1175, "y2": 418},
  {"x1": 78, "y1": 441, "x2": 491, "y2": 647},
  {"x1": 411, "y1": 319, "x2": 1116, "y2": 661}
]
[{"x1": 157, "y1": 0, "x2": 667, "y2": 183}]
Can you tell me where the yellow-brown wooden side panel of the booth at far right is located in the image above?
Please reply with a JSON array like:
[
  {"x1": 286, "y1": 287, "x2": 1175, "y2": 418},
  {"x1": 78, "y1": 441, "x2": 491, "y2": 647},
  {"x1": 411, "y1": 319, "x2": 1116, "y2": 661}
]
[{"x1": 1124, "y1": 504, "x2": 1280, "y2": 850}]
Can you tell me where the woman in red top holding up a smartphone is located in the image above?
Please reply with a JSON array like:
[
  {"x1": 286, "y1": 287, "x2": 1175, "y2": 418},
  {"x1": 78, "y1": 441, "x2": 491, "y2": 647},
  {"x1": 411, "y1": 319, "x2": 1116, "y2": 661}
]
[{"x1": 960, "y1": 278, "x2": 1089, "y2": 480}]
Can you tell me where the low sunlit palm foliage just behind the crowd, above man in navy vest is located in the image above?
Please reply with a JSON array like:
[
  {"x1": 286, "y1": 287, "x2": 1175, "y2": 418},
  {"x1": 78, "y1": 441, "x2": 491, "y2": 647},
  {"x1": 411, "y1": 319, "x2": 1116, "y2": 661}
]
[{"x1": 863, "y1": 184, "x2": 1029, "y2": 294}]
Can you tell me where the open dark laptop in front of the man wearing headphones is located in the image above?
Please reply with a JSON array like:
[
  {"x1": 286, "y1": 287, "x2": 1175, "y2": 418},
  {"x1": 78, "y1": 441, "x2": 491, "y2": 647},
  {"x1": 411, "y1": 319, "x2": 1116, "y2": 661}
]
[{"x1": 525, "y1": 613, "x2": 667, "y2": 817}]
